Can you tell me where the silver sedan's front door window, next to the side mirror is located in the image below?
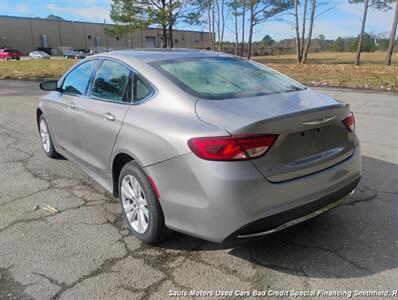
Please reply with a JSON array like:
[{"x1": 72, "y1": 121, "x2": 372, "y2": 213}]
[{"x1": 62, "y1": 60, "x2": 99, "y2": 95}]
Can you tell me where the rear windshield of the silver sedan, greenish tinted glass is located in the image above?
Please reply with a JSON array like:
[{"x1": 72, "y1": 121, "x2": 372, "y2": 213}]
[{"x1": 152, "y1": 57, "x2": 305, "y2": 99}]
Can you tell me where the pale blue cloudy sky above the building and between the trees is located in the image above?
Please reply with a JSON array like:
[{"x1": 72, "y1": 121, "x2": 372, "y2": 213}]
[{"x1": 0, "y1": 0, "x2": 394, "y2": 40}]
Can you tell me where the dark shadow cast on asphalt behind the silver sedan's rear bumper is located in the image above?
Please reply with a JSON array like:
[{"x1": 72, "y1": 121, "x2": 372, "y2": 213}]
[{"x1": 158, "y1": 157, "x2": 398, "y2": 278}]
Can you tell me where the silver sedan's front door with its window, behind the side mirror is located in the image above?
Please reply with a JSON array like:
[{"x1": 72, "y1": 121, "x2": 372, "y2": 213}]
[{"x1": 47, "y1": 60, "x2": 100, "y2": 154}]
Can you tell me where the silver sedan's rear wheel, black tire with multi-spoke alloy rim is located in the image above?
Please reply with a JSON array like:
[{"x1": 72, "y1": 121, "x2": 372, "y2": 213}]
[{"x1": 118, "y1": 161, "x2": 170, "y2": 244}]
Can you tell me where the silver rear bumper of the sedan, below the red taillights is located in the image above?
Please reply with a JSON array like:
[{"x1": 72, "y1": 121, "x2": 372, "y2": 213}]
[{"x1": 145, "y1": 145, "x2": 361, "y2": 242}]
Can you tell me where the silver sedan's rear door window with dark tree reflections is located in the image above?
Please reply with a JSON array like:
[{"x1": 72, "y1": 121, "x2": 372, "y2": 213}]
[{"x1": 91, "y1": 60, "x2": 131, "y2": 102}]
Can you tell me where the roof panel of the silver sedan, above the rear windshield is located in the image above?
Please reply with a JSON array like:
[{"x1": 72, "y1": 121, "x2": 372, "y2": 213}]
[{"x1": 100, "y1": 48, "x2": 232, "y2": 63}]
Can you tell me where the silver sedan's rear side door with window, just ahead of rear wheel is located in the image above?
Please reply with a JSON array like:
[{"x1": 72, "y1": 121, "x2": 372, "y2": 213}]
[{"x1": 76, "y1": 60, "x2": 132, "y2": 179}]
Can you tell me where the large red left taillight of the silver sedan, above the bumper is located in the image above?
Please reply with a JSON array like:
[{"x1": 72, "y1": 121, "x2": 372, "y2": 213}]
[{"x1": 188, "y1": 135, "x2": 277, "y2": 161}]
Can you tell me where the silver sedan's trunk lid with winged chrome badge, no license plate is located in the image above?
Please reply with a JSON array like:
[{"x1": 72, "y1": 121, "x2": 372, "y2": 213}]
[{"x1": 196, "y1": 89, "x2": 355, "y2": 183}]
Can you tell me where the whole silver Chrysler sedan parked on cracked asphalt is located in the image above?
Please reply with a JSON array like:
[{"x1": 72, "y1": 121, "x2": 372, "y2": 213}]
[{"x1": 37, "y1": 50, "x2": 361, "y2": 243}]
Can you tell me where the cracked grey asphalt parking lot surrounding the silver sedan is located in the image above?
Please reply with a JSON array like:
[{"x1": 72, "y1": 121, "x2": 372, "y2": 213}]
[{"x1": 0, "y1": 81, "x2": 398, "y2": 299}]
